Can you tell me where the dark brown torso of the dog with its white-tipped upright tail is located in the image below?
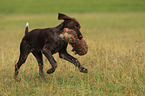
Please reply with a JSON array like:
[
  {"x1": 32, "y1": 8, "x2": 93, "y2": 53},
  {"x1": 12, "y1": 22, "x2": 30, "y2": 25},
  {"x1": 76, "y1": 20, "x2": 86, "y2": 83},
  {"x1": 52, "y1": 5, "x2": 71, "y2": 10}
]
[{"x1": 22, "y1": 25, "x2": 64, "y2": 53}]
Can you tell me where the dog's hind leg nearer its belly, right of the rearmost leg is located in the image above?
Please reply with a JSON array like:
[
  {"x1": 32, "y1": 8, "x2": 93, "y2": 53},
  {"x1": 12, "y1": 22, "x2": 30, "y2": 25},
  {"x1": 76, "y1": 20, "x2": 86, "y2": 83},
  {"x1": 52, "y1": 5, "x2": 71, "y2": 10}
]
[{"x1": 32, "y1": 51, "x2": 47, "y2": 81}]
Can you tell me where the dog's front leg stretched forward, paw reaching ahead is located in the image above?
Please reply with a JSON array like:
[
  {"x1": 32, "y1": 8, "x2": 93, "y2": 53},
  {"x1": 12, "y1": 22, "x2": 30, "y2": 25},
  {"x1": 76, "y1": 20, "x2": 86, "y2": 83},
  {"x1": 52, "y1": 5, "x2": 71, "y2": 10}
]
[{"x1": 59, "y1": 50, "x2": 88, "y2": 73}]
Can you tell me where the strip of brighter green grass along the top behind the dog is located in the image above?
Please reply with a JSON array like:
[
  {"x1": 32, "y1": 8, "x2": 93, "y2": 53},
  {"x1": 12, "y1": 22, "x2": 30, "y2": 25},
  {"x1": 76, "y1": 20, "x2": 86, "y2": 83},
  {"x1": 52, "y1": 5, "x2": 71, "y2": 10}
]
[{"x1": 0, "y1": 0, "x2": 145, "y2": 14}]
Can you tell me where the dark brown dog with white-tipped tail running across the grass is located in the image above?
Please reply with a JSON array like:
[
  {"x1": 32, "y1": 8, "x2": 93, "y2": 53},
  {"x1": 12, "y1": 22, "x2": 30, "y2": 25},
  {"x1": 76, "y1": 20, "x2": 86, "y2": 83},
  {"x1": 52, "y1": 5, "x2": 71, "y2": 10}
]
[{"x1": 14, "y1": 13, "x2": 88, "y2": 81}]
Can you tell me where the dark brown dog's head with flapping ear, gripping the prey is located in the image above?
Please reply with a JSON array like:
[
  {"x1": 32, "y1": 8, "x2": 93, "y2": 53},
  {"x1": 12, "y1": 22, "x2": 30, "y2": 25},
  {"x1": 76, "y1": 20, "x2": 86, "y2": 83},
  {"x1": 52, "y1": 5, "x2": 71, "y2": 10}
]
[{"x1": 58, "y1": 13, "x2": 83, "y2": 40}]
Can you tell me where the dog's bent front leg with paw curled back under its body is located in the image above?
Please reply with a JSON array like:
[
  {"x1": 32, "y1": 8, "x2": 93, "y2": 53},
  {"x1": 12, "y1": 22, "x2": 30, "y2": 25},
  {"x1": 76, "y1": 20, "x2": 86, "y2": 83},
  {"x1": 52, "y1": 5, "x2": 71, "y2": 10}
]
[{"x1": 42, "y1": 48, "x2": 57, "y2": 74}]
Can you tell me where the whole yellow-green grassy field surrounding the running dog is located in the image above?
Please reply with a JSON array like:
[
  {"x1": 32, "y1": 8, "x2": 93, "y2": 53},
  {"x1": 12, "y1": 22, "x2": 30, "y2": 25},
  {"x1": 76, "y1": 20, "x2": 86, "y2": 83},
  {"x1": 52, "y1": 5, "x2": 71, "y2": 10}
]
[{"x1": 0, "y1": 0, "x2": 145, "y2": 96}]
